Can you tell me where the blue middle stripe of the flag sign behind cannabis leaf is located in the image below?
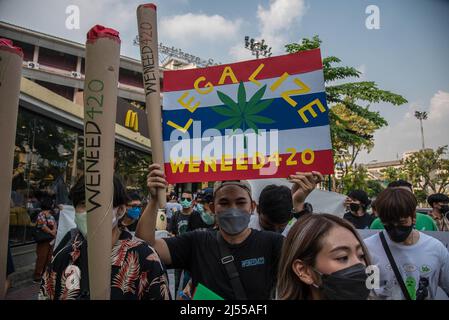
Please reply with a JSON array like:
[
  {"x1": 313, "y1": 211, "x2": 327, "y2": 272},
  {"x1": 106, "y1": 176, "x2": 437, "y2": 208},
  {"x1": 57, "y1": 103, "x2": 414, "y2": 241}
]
[{"x1": 162, "y1": 92, "x2": 329, "y2": 141}]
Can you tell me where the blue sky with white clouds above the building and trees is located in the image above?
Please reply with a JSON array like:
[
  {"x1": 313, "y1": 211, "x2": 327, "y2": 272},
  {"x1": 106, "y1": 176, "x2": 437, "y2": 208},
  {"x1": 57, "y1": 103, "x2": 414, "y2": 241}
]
[{"x1": 0, "y1": 0, "x2": 449, "y2": 163}]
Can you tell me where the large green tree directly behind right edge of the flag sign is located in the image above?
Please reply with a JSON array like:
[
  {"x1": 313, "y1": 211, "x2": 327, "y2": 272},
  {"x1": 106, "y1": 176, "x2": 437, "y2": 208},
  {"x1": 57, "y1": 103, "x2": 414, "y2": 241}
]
[{"x1": 285, "y1": 36, "x2": 407, "y2": 179}]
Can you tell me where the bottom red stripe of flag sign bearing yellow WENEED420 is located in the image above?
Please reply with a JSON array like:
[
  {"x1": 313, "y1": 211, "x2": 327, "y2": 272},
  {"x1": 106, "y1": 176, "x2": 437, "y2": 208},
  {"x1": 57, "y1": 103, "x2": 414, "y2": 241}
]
[{"x1": 164, "y1": 150, "x2": 334, "y2": 184}]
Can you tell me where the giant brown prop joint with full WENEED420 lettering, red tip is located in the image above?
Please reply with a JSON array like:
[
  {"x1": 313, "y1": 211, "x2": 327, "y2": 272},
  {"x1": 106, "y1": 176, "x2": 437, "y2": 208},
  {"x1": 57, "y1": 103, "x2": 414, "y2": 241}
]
[{"x1": 84, "y1": 25, "x2": 120, "y2": 300}]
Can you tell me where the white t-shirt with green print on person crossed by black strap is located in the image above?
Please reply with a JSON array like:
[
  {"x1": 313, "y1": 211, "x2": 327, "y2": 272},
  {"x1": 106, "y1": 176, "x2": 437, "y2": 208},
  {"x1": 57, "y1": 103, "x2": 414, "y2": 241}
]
[{"x1": 365, "y1": 232, "x2": 449, "y2": 300}]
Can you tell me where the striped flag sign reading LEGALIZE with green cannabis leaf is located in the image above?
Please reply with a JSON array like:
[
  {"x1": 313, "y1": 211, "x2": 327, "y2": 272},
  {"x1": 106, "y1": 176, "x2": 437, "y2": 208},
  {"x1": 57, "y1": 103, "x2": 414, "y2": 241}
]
[{"x1": 162, "y1": 49, "x2": 333, "y2": 183}]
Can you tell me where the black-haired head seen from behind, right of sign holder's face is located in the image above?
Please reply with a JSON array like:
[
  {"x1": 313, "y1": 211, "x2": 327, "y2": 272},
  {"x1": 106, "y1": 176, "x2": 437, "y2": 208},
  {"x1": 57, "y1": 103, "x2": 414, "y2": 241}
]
[{"x1": 259, "y1": 184, "x2": 293, "y2": 224}]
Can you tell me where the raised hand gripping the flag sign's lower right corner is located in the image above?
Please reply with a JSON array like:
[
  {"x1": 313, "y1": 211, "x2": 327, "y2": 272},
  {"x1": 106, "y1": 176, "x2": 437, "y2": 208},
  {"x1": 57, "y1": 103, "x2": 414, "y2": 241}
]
[{"x1": 288, "y1": 171, "x2": 323, "y2": 211}]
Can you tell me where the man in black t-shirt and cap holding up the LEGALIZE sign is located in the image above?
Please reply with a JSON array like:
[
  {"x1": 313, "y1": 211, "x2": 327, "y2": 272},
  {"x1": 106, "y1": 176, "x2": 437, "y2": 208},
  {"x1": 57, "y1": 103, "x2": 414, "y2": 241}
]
[{"x1": 136, "y1": 164, "x2": 322, "y2": 300}]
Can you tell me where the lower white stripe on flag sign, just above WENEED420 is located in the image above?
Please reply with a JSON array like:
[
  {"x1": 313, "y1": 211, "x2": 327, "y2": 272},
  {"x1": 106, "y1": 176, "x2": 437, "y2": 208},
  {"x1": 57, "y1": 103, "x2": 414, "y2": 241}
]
[{"x1": 164, "y1": 125, "x2": 332, "y2": 163}]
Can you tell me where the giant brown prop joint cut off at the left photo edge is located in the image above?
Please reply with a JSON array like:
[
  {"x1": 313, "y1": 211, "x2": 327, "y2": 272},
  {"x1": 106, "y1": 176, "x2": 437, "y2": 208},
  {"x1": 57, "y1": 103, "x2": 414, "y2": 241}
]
[{"x1": 0, "y1": 39, "x2": 23, "y2": 299}]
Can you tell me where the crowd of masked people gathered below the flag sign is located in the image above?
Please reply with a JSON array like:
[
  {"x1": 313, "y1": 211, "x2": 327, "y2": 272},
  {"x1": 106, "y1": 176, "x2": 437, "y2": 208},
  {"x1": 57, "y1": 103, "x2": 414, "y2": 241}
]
[{"x1": 7, "y1": 164, "x2": 449, "y2": 300}]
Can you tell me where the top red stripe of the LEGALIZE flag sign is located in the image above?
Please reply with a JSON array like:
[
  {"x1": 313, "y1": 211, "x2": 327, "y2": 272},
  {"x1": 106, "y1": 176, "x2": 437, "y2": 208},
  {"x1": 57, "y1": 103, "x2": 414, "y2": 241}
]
[{"x1": 164, "y1": 49, "x2": 323, "y2": 92}]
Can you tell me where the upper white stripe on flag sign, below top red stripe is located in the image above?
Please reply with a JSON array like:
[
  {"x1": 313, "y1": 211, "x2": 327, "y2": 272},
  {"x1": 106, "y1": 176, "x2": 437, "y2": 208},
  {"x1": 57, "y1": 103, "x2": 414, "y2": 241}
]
[{"x1": 163, "y1": 70, "x2": 324, "y2": 110}]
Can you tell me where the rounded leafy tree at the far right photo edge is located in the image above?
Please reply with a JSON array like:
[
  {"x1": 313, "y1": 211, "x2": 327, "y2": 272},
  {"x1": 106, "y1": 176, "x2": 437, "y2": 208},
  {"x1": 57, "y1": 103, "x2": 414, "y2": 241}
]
[{"x1": 403, "y1": 145, "x2": 449, "y2": 194}]
